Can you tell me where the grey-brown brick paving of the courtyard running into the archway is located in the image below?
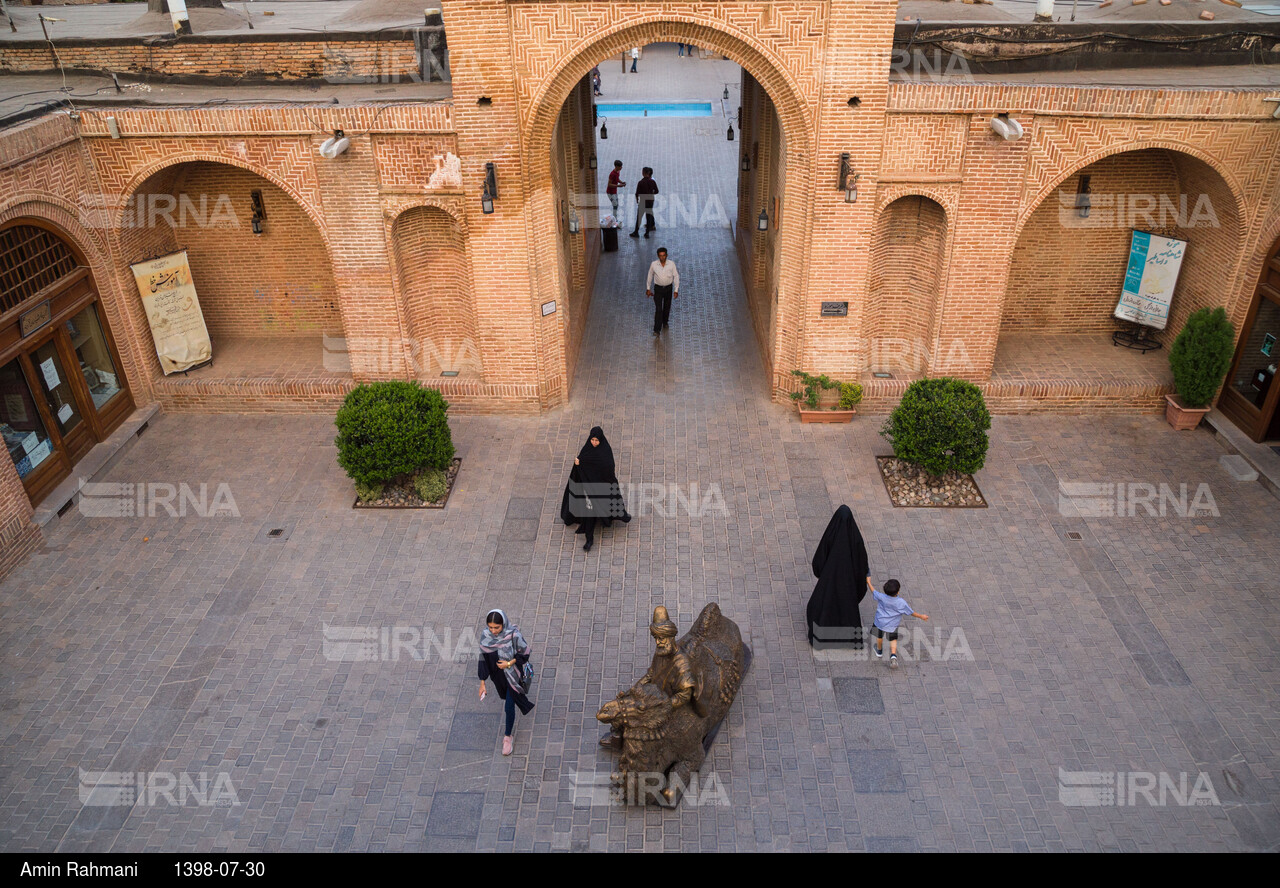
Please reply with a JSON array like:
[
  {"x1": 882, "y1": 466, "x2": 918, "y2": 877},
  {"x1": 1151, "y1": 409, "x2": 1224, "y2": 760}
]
[{"x1": 0, "y1": 43, "x2": 1280, "y2": 852}]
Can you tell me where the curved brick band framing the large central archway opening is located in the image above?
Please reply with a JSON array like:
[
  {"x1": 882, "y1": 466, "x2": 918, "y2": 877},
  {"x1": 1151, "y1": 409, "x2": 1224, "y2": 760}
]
[{"x1": 521, "y1": 17, "x2": 814, "y2": 397}]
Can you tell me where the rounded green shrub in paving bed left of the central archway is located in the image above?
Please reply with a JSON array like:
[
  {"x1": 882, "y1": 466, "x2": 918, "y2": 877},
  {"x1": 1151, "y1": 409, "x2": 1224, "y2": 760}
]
[{"x1": 334, "y1": 381, "x2": 453, "y2": 485}]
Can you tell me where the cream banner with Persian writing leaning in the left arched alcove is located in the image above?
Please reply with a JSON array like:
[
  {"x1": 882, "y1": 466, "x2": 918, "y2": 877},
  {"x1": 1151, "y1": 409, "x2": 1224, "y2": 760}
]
[{"x1": 129, "y1": 251, "x2": 214, "y2": 376}]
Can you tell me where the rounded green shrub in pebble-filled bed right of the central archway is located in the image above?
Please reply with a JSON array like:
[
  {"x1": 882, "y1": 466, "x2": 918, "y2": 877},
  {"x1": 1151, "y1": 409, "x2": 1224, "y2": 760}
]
[{"x1": 881, "y1": 377, "x2": 991, "y2": 475}]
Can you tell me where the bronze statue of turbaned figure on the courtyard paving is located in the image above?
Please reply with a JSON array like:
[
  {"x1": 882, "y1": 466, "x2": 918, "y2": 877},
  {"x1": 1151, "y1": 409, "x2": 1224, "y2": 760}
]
[{"x1": 595, "y1": 601, "x2": 751, "y2": 807}]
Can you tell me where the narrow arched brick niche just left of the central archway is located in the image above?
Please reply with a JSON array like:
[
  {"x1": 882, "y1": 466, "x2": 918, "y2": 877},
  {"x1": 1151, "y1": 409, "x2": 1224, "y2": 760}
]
[{"x1": 393, "y1": 207, "x2": 483, "y2": 379}]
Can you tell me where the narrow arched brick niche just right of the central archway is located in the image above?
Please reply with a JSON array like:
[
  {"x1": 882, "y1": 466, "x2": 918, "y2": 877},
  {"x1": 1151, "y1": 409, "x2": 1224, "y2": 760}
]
[{"x1": 863, "y1": 194, "x2": 947, "y2": 374}]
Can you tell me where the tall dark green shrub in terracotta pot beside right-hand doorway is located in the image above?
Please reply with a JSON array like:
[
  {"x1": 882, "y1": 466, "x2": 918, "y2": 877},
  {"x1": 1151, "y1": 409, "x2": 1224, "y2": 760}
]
[{"x1": 1165, "y1": 307, "x2": 1235, "y2": 431}]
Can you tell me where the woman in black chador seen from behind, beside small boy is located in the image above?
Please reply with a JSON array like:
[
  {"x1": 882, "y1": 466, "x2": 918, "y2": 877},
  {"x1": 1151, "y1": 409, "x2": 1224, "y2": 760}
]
[{"x1": 806, "y1": 505, "x2": 872, "y2": 647}]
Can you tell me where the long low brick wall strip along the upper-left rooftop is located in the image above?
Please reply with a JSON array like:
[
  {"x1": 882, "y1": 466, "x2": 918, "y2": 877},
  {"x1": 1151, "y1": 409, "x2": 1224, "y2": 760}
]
[{"x1": 0, "y1": 38, "x2": 419, "y2": 83}]
